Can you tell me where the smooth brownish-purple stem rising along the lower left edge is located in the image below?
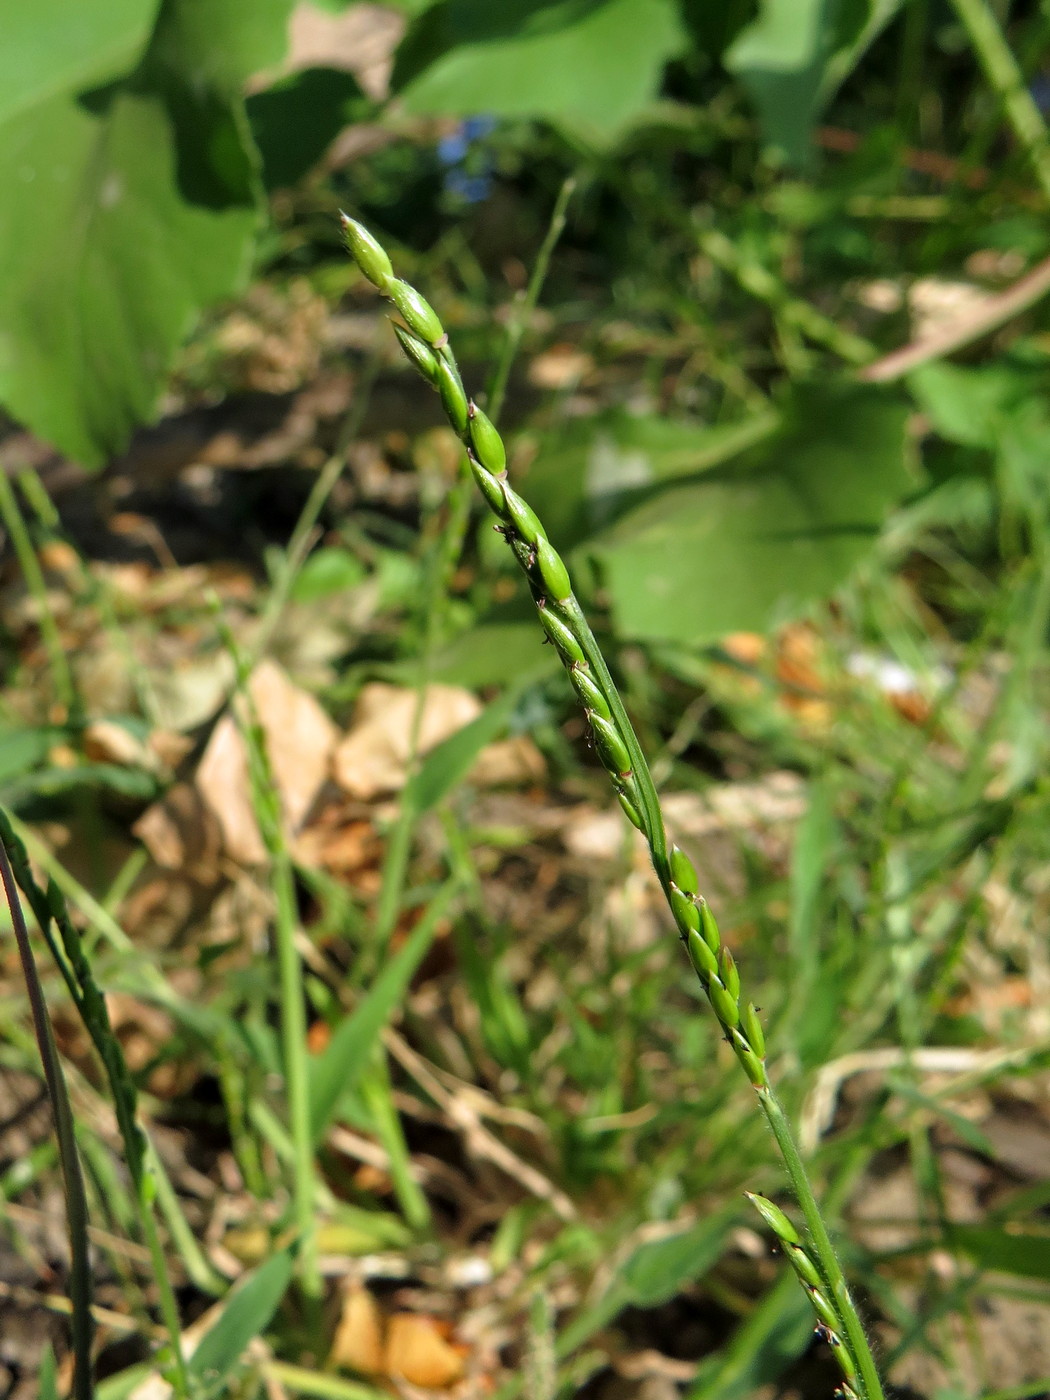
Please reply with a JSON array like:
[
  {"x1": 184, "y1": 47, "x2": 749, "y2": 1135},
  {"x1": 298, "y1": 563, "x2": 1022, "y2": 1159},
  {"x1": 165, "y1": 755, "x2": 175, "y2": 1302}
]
[{"x1": 0, "y1": 828, "x2": 95, "y2": 1400}]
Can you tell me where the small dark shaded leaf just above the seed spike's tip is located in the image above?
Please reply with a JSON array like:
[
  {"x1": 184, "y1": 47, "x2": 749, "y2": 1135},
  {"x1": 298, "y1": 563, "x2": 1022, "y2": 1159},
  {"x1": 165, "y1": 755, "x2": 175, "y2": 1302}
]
[{"x1": 246, "y1": 69, "x2": 374, "y2": 189}]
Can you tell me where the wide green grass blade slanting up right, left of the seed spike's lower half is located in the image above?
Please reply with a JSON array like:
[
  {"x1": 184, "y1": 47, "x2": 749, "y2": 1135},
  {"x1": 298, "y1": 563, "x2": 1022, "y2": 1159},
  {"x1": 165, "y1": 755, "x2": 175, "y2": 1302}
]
[{"x1": 309, "y1": 896, "x2": 447, "y2": 1141}]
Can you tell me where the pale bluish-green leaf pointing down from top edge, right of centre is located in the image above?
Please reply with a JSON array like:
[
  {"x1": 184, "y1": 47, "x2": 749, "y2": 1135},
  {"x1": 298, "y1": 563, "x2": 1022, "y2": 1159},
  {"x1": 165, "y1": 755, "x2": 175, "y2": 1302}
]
[{"x1": 725, "y1": 0, "x2": 903, "y2": 165}]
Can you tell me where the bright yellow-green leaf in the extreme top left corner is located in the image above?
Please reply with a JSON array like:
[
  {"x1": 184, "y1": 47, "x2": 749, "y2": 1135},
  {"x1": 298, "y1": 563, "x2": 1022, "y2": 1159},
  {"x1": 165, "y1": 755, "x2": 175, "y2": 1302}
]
[{"x1": 0, "y1": 0, "x2": 160, "y2": 123}]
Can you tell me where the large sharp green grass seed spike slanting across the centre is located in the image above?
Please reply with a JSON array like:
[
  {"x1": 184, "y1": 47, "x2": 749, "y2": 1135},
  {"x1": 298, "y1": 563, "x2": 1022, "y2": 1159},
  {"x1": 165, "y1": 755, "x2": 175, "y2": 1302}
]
[{"x1": 343, "y1": 216, "x2": 882, "y2": 1400}]
